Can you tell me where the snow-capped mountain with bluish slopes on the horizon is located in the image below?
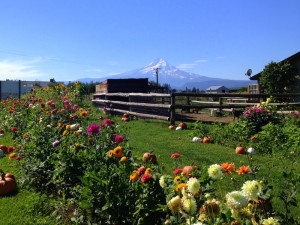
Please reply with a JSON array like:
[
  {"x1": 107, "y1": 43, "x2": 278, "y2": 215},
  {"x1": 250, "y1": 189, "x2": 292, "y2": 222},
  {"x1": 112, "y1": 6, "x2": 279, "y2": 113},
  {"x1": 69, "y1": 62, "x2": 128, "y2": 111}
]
[{"x1": 79, "y1": 58, "x2": 253, "y2": 90}]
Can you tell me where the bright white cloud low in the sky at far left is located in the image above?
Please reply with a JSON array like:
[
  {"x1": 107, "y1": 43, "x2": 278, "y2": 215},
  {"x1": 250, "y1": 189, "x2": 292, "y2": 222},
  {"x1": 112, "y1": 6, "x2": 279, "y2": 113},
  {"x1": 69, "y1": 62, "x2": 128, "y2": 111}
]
[{"x1": 0, "y1": 58, "x2": 45, "y2": 80}]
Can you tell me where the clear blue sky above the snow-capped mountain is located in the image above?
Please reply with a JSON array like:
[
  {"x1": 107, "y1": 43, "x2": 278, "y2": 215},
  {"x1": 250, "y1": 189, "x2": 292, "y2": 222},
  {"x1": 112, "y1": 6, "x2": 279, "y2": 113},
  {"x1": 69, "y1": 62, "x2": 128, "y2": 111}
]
[{"x1": 0, "y1": 0, "x2": 300, "y2": 81}]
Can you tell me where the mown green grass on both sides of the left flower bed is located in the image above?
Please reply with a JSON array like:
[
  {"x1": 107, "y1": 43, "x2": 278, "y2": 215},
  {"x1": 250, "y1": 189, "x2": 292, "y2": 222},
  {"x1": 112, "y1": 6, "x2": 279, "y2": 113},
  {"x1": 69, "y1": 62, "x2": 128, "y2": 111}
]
[{"x1": 0, "y1": 118, "x2": 300, "y2": 225}]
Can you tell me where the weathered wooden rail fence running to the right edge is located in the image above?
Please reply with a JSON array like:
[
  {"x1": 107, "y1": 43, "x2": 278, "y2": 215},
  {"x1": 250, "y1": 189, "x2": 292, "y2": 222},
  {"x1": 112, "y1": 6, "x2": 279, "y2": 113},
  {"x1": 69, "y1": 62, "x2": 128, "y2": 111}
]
[{"x1": 92, "y1": 93, "x2": 300, "y2": 124}]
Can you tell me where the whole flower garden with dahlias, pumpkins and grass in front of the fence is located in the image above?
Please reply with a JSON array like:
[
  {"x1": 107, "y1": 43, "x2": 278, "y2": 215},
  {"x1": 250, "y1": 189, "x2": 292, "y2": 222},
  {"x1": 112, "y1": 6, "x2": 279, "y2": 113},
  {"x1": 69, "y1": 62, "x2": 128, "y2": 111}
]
[{"x1": 0, "y1": 83, "x2": 300, "y2": 225}]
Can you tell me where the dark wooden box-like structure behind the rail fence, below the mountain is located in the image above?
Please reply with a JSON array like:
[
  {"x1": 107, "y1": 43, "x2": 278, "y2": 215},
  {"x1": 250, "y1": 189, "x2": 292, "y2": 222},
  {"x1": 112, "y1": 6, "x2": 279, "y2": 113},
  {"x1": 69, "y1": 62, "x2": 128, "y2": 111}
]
[{"x1": 96, "y1": 78, "x2": 148, "y2": 94}]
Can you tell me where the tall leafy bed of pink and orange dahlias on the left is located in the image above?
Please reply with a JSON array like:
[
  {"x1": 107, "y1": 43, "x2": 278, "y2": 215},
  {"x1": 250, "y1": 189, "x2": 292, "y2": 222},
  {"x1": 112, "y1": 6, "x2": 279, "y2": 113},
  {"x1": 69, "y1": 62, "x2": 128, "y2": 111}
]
[{"x1": 2, "y1": 83, "x2": 165, "y2": 224}]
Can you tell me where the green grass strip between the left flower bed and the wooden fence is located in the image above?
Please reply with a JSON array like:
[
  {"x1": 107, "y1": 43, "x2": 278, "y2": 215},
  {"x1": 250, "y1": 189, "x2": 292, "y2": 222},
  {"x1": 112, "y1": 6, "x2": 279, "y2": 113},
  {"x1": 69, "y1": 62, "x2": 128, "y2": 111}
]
[{"x1": 125, "y1": 120, "x2": 300, "y2": 217}]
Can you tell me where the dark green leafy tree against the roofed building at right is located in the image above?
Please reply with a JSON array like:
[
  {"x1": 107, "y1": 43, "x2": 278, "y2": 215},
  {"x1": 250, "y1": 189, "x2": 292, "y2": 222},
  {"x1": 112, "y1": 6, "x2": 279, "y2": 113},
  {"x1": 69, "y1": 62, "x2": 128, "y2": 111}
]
[{"x1": 259, "y1": 61, "x2": 299, "y2": 94}]
